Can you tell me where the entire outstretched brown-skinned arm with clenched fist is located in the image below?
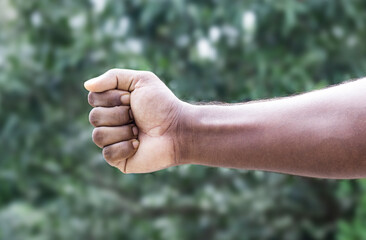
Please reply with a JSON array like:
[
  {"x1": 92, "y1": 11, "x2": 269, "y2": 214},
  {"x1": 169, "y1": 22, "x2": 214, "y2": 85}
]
[{"x1": 85, "y1": 69, "x2": 366, "y2": 178}]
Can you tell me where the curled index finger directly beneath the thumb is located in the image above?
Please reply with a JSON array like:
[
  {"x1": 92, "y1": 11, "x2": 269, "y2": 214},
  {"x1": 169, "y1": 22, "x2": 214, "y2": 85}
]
[{"x1": 88, "y1": 90, "x2": 130, "y2": 107}]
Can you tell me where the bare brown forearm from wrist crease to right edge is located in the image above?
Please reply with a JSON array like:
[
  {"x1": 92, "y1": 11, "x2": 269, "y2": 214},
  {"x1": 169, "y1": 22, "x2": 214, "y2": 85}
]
[{"x1": 178, "y1": 80, "x2": 366, "y2": 178}]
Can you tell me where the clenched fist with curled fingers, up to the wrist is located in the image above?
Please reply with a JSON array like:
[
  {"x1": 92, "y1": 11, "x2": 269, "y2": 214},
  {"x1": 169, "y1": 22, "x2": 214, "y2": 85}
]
[{"x1": 84, "y1": 69, "x2": 184, "y2": 173}]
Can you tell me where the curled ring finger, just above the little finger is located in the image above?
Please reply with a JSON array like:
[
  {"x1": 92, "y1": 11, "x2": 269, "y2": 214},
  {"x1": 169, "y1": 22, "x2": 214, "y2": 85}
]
[{"x1": 93, "y1": 124, "x2": 138, "y2": 148}]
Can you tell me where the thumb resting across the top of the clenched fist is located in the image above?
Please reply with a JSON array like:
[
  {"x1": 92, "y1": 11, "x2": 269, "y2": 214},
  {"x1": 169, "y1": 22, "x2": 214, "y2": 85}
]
[{"x1": 84, "y1": 69, "x2": 142, "y2": 92}]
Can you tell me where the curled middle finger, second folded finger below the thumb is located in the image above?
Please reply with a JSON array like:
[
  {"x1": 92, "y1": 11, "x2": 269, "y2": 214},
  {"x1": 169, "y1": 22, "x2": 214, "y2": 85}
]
[{"x1": 89, "y1": 106, "x2": 132, "y2": 127}]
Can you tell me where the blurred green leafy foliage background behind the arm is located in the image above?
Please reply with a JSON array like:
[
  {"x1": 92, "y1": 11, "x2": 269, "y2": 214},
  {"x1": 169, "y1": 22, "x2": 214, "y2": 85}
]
[{"x1": 0, "y1": 0, "x2": 366, "y2": 240}]
